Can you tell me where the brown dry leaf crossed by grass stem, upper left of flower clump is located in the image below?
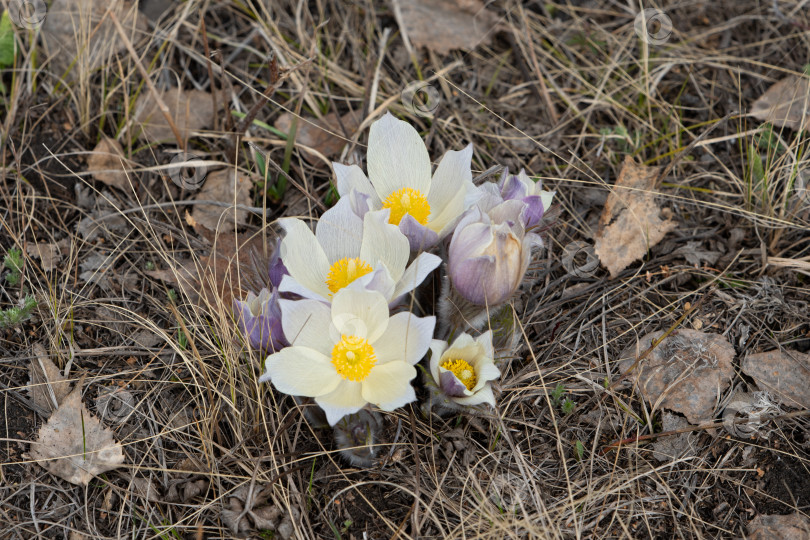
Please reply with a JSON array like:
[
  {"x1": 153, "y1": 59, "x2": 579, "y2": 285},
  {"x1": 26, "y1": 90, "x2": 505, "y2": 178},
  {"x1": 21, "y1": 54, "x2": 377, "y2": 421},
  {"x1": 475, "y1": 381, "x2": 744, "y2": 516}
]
[{"x1": 191, "y1": 169, "x2": 252, "y2": 231}]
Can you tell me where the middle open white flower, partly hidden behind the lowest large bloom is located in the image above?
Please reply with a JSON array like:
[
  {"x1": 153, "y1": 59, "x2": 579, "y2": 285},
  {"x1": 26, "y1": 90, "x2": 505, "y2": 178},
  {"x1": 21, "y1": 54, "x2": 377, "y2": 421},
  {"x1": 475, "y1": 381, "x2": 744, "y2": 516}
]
[{"x1": 279, "y1": 194, "x2": 441, "y2": 304}]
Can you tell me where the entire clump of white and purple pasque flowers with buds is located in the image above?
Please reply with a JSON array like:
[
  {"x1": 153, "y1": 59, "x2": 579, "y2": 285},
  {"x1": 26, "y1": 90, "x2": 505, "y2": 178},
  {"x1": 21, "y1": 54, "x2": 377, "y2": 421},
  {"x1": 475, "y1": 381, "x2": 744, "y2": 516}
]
[{"x1": 234, "y1": 114, "x2": 554, "y2": 456}]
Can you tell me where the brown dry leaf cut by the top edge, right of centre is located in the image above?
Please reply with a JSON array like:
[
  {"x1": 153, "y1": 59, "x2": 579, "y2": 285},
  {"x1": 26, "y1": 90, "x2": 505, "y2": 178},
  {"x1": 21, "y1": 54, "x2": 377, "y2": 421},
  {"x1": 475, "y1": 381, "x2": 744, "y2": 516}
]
[{"x1": 391, "y1": 0, "x2": 497, "y2": 54}]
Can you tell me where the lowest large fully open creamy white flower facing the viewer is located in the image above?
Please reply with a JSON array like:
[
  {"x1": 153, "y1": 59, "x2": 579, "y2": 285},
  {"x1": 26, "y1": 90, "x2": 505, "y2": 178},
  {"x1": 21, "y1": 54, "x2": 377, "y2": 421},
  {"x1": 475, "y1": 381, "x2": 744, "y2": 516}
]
[{"x1": 259, "y1": 288, "x2": 436, "y2": 425}]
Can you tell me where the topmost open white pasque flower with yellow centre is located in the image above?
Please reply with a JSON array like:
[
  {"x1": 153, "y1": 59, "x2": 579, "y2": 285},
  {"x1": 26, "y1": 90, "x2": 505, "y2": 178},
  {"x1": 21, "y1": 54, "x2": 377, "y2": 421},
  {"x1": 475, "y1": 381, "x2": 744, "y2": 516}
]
[{"x1": 332, "y1": 113, "x2": 478, "y2": 251}]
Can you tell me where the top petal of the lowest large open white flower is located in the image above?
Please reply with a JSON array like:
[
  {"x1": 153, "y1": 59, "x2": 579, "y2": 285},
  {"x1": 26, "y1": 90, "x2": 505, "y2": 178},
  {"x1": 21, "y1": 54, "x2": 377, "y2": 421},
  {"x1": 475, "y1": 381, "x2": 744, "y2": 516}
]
[{"x1": 330, "y1": 288, "x2": 388, "y2": 345}]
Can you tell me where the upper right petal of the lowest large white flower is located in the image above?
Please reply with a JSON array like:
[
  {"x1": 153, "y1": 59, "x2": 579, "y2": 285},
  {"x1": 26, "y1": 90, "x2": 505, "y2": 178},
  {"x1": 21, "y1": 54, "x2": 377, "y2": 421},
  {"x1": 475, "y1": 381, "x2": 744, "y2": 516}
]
[{"x1": 371, "y1": 312, "x2": 436, "y2": 365}]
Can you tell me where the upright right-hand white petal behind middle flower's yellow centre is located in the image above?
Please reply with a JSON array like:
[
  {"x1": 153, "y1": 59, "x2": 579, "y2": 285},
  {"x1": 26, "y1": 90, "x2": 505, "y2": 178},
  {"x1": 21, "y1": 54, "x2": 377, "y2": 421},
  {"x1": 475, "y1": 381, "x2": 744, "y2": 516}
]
[{"x1": 360, "y1": 209, "x2": 411, "y2": 282}]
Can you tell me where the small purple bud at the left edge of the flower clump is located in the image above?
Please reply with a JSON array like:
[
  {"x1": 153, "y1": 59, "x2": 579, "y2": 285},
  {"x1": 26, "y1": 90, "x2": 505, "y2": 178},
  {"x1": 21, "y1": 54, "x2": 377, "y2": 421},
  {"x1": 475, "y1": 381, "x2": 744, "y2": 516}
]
[{"x1": 233, "y1": 288, "x2": 289, "y2": 354}]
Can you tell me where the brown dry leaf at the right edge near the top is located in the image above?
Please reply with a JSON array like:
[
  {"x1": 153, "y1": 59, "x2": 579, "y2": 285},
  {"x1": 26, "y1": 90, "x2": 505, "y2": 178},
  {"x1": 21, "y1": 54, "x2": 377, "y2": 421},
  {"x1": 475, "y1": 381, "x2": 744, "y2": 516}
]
[{"x1": 749, "y1": 75, "x2": 810, "y2": 129}]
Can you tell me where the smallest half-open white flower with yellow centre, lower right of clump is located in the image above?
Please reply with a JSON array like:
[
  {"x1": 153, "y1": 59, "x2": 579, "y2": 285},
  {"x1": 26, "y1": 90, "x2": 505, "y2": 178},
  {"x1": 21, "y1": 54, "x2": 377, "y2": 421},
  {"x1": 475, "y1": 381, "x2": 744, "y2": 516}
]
[{"x1": 430, "y1": 330, "x2": 501, "y2": 407}]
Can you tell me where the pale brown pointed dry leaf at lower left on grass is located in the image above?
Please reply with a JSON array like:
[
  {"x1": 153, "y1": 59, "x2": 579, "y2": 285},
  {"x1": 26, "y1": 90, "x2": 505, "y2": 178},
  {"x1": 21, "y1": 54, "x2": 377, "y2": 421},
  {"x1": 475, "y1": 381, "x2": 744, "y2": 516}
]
[{"x1": 31, "y1": 382, "x2": 124, "y2": 486}]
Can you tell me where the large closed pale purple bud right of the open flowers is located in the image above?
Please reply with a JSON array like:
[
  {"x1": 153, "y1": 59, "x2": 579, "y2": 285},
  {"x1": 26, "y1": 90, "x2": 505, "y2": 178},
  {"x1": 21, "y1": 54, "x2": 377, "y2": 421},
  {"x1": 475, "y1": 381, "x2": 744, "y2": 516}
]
[{"x1": 447, "y1": 199, "x2": 542, "y2": 309}]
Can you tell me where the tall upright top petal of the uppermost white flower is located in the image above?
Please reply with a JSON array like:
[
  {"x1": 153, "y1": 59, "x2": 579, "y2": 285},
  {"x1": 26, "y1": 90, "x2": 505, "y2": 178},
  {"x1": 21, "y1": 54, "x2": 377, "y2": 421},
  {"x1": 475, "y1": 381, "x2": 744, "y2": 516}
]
[{"x1": 367, "y1": 113, "x2": 430, "y2": 200}]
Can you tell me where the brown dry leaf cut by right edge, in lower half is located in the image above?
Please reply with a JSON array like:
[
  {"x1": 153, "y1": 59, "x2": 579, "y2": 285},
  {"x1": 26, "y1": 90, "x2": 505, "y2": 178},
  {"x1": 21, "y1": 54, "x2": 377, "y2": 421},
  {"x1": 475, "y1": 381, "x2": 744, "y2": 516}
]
[{"x1": 742, "y1": 350, "x2": 810, "y2": 409}]
